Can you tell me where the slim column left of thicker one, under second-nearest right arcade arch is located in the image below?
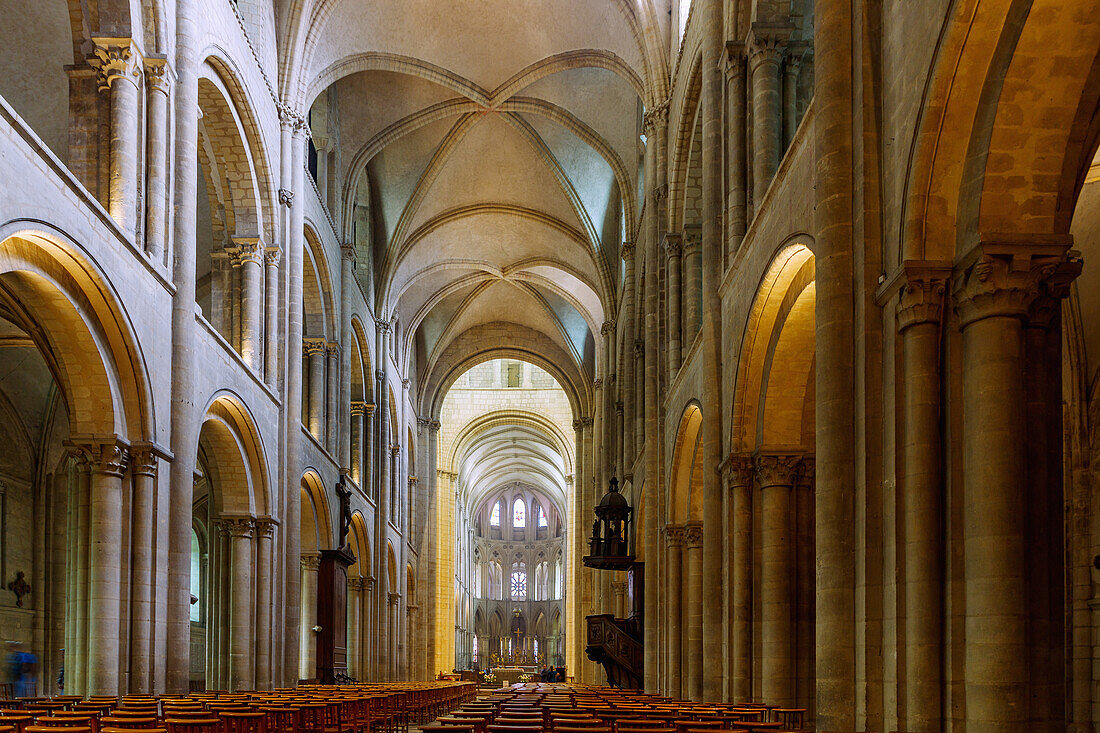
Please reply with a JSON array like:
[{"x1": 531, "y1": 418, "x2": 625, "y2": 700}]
[{"x1": 726, "y1": 456, "x2": 755, "y2": 702}]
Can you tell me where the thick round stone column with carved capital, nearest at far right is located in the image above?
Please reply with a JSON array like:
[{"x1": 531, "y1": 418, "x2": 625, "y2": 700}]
[{"x1": 954, "y1": 244, "x2": 1057, "y2": 733}]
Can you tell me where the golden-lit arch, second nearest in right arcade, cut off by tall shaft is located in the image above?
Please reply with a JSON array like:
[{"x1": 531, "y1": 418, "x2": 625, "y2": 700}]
[{"x1": 730, "y1": 243, "x2": 816, "y2": 453}]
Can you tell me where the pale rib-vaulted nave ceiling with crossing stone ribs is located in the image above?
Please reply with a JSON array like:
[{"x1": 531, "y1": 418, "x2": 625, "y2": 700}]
[{"x1": 299, "y1": 0, "x2": 647, "y2": 394}]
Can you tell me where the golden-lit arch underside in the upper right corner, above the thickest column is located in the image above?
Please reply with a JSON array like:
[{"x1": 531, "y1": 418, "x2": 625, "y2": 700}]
[{"x1": 900, "y1": 0, "x2": 1100, "y2": 261}]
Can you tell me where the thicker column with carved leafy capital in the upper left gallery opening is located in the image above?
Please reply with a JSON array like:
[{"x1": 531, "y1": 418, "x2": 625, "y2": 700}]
[{"x1": 92, "y1": 39, "x2": 142, "y2": 238}]
